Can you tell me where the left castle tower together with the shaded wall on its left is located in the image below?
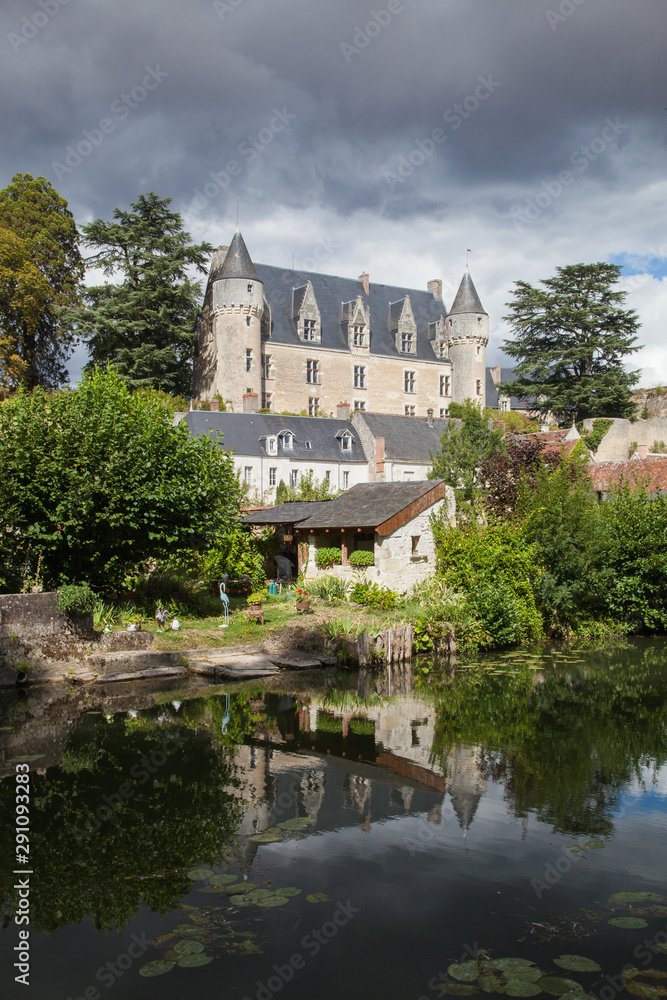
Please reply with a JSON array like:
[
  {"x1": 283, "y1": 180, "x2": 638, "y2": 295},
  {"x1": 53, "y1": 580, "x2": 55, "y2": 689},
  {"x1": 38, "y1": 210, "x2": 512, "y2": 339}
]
[{"x1": 195, "y1": 226, "x2": 264, "y2": 413}]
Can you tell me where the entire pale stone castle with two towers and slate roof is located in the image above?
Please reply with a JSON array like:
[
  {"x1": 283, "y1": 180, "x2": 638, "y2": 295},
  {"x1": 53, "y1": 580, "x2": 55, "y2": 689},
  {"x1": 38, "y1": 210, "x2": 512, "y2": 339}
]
[{"x1": 194, "y1": 227, "x2": 489, "y2": 419}]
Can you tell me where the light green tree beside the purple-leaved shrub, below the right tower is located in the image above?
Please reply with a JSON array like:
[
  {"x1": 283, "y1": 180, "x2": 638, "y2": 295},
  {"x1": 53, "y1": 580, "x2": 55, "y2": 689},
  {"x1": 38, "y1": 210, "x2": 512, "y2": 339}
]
[{"x1": 429, "y1": 399, "x2": 505, "y2": 508}]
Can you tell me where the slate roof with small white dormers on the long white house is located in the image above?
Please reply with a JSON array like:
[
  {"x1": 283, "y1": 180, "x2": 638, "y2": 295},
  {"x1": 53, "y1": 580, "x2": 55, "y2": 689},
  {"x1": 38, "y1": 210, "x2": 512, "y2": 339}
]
[{"x1": 183, "y1": 410, "x2": 367, "y2": 464}]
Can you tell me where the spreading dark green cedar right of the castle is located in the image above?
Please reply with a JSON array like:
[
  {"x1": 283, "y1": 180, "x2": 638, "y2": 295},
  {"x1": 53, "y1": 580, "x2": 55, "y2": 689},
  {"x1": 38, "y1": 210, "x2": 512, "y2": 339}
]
[{"x1": 503, "y1": 263, "x2": 639, "y2": 423}]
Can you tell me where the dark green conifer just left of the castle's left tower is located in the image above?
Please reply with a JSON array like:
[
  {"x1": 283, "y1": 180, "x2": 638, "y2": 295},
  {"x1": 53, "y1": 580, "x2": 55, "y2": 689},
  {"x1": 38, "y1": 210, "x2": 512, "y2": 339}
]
[{"x1": 69, "y1": 193, "x2": 213, "y2": 396}]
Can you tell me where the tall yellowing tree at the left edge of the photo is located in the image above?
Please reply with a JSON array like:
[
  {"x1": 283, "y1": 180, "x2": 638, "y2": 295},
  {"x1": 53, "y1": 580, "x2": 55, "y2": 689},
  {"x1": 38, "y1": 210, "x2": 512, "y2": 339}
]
[{"x1": 0, "y1": 174, "x2": 84, "y2": 389}]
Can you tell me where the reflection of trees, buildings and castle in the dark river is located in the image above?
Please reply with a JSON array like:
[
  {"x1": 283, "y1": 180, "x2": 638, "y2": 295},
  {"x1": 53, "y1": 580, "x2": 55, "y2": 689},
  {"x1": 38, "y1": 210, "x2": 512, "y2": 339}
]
[{"x1": 0, "y1": 642, "x2": 667, "y2": 997}]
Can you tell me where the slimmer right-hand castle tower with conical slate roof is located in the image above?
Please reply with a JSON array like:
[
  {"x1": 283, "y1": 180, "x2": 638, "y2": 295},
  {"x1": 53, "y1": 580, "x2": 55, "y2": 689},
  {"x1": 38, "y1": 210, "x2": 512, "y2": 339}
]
[{"x1": 445, "y1": 271, "x2": 489, "y2": 407}]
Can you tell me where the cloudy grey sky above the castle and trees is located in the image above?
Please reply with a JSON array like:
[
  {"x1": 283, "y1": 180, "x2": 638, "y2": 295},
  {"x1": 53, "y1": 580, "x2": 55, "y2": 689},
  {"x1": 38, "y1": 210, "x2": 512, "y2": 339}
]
[{"x1": 0, "y1": 0, "x2": 667, "y2": 386}]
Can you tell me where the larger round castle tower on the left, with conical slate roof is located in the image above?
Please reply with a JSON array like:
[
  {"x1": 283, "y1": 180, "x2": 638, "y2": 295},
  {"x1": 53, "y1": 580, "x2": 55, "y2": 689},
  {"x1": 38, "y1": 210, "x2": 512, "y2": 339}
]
[{"x1": 211, "y1": 226, "x2": 264, "y2": 412}]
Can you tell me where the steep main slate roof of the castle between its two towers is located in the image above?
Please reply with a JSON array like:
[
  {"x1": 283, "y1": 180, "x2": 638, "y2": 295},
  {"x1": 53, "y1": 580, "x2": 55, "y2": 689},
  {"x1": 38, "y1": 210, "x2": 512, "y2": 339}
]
[{"x1": 257, "y1": 264, "x2": 450, "y2": 366}]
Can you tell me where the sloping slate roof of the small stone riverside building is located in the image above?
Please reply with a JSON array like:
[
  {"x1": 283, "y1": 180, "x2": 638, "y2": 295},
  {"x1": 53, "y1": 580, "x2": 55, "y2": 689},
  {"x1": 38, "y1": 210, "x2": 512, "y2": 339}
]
[{"x1": 297, "y1": 479, "x2": 445, "y2": 529}]
